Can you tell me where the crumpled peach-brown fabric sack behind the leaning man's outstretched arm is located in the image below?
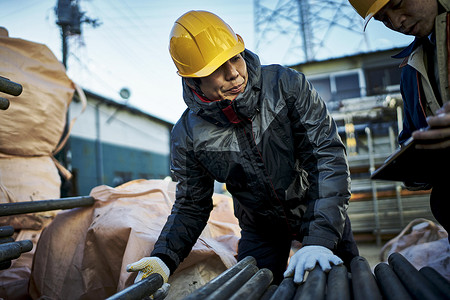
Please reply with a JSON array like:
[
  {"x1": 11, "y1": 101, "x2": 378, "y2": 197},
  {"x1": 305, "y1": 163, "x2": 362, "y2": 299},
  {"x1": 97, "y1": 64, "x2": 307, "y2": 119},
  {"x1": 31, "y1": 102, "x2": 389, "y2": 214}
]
[{"x1": 29, "y1": 180, "x2": 240, "y2": 299}]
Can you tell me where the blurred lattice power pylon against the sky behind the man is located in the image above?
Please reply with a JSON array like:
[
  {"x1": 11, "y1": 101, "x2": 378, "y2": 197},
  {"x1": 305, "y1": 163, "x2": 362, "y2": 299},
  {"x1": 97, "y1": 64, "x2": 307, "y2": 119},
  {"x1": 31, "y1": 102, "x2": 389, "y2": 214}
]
[{"x1": 254, "y1": 0, "x2": 370, "y2": 64}]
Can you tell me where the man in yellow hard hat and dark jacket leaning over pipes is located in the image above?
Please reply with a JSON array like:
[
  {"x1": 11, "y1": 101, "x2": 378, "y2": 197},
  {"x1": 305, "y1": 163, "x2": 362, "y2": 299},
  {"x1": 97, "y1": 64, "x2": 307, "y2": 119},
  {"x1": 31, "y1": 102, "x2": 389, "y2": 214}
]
[{"x1": 128, "y1": 11, "x2": 358, "y2": 284}]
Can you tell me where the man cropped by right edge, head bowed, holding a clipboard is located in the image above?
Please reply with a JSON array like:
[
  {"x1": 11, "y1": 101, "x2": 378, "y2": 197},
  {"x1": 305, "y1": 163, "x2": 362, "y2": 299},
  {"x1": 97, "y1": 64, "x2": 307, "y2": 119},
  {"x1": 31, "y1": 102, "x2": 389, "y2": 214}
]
[{"x1": 349, "y1": 0, "x2": 450, "y2": 239}]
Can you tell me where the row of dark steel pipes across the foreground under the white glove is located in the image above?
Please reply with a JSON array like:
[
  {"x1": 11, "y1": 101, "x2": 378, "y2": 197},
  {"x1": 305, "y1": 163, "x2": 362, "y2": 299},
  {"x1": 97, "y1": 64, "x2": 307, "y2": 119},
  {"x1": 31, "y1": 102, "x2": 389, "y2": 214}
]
[{"x1": 184, "y1": 253, "x2": 450, "y2": 300}]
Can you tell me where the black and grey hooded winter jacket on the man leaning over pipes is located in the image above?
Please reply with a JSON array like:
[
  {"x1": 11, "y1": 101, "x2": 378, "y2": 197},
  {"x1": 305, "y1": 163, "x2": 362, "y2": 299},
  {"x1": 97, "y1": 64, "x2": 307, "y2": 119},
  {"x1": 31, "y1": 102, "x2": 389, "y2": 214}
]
[{"x1": 151, "y1": 50, "x2": 350, "y2": 272}]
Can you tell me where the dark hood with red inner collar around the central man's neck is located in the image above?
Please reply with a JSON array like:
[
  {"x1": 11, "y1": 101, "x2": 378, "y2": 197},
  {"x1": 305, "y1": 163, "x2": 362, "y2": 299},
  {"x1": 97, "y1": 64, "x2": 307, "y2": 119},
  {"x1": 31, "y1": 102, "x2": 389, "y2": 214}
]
[{"x1": 183, "y1": 49, "x2": 261, "y2": 126}]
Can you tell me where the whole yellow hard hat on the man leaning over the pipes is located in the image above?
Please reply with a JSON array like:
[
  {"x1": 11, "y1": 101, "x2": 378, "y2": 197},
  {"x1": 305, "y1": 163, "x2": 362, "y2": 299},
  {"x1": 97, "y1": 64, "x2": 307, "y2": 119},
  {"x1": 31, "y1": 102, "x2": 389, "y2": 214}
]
[{"x1": 169, "y1": 11, "x2": 245, "y2": 77}]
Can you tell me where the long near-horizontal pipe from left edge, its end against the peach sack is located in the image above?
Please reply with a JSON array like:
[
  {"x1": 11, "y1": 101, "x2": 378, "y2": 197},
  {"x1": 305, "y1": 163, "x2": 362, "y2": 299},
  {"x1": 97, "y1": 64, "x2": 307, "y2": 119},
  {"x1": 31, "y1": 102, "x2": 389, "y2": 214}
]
[{"x1": 0, "y1": 196, "x2": 95, "y2": 216}]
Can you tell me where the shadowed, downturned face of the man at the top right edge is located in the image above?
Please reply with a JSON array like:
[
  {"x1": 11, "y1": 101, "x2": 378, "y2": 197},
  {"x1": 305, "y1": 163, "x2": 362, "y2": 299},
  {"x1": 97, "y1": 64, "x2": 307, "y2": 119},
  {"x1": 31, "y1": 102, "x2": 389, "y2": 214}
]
[{"x1": 374, "y1": 0, "x2": 438, "y2": 37}]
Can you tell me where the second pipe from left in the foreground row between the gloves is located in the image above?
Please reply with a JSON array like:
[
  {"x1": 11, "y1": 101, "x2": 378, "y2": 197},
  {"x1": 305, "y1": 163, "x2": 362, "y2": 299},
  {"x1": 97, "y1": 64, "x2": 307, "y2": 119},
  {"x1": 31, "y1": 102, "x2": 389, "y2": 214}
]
[{"x1": 206, "y1": 264, "x2": 258, "y2": 300}]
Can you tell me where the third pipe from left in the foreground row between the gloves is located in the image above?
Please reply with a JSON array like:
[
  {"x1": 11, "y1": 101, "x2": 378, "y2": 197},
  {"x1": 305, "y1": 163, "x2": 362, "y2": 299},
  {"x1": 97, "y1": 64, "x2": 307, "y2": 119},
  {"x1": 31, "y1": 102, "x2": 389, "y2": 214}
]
[{"x1": 229, "y1": 268, "x2": 273, "y2": 300}]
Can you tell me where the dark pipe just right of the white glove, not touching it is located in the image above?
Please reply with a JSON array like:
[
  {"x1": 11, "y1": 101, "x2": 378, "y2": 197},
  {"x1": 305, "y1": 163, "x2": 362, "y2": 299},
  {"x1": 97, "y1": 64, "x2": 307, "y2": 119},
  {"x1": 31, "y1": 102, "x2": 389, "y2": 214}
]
[{"x1": 350, "y1": 256, "x2": 382, "y2": 300}]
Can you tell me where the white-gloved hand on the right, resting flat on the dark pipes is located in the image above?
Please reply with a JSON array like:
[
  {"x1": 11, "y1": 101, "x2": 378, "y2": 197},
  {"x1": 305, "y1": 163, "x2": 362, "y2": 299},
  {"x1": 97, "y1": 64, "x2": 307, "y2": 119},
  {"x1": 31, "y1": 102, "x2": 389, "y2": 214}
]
[{"x1": 284, "y1": 246, "x2": 344, "y2": 283}]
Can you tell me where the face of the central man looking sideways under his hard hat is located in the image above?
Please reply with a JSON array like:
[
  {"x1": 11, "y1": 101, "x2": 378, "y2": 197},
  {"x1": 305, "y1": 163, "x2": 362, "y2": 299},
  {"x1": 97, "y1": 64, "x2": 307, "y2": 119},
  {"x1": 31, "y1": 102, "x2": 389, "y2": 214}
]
[{"x1": 200, "y1": 54, "x2": 248, "y2": 100}]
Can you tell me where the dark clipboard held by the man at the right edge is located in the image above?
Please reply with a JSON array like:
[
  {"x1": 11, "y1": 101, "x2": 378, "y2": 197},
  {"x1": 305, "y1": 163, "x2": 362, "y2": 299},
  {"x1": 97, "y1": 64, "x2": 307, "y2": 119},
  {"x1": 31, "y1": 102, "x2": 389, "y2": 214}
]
[{"x1": 370, "y1": 137, "x2": 450, "y2": 185}]
